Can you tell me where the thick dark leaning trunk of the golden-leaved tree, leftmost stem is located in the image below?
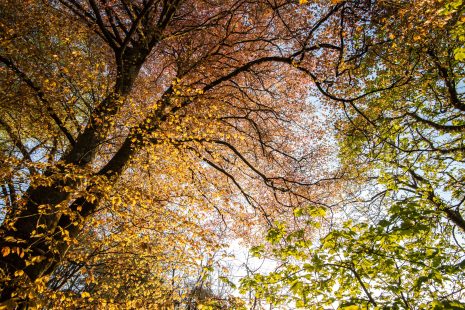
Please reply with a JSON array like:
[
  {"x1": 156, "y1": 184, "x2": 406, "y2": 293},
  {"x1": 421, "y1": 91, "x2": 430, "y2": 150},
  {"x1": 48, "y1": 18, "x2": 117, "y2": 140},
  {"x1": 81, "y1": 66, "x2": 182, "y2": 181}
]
[{"x1": 0, "y1": 48, "x2": 150, "y2": 306}]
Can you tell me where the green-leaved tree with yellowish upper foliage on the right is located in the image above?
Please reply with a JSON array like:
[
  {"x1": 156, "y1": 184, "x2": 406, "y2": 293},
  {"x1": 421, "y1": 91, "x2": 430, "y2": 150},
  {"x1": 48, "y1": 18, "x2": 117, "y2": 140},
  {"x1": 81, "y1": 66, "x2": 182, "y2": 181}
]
[{"x1": 244, "y1": 1, "x2": 465, "y2": 309}]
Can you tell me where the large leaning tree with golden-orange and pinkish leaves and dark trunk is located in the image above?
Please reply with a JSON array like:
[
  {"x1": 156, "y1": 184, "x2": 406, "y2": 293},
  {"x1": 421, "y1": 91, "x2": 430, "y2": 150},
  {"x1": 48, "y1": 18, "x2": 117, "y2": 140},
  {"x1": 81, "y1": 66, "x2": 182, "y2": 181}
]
[{"x1": 0, "y1": 0, "x2": 370, "y2": 306}]
